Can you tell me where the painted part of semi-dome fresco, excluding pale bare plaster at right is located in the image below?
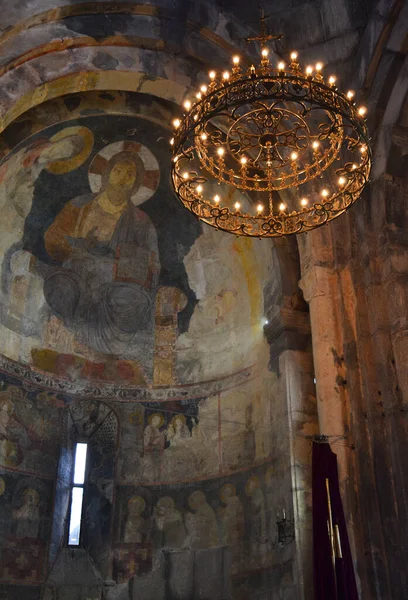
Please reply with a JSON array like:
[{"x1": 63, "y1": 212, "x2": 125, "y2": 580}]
[{"x1": 0, "y1": 104, "x2": 200, "y2": 385}]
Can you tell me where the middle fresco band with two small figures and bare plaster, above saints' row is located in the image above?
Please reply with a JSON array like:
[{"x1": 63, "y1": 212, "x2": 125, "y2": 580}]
[{"x1": 117, "y1": 375, "x2": 273, "y2": 484}]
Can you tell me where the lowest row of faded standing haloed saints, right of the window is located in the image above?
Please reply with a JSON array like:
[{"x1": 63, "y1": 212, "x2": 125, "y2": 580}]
[{"x1": 114, "y1": 464, "x2": 276, "y2": 581}]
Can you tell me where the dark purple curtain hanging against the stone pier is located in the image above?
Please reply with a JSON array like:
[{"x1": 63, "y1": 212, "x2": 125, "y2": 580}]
[{"x1": 312, "y1": 442, "x2": 358, "y2": 600}]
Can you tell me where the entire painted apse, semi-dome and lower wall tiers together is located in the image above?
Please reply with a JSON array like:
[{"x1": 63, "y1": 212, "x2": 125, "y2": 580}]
[{"x1": 0, "y1": 92, "x2": 291, "y2": 600}]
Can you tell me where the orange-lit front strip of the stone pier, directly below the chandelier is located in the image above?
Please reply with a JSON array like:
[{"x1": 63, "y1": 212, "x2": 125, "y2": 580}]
[{"x1": 299, "y1": 220, "x2": 356, "y2": 576}]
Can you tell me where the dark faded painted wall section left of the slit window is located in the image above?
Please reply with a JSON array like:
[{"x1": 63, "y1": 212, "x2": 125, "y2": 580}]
[{"x1": 0, "y1": 374, "x2": 60, "y2": 598}]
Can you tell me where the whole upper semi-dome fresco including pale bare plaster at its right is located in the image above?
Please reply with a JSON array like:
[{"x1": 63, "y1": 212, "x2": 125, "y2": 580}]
[{"x1": 0, "y1": 97, "x2": 270, "y2": 386}]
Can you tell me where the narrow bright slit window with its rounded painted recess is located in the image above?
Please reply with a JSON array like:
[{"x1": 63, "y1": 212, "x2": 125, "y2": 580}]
[{"x1": 50, "y1": 400, "x2": 118, "y2": 576}]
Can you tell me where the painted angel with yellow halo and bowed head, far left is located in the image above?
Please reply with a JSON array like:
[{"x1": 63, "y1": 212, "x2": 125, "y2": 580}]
[{"x1": 0, "y1": 126, "x2": 93, "y2": 335}]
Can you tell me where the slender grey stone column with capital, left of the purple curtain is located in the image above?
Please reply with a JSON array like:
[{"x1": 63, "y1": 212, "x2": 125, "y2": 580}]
[{"x1": 265, "y1": 298, "x2": 318, "y2": 600}]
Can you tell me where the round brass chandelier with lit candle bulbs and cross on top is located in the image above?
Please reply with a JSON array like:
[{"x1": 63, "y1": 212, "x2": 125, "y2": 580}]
[{"x1": 171, "y1": 26, "x2": 371, "y2": 238}]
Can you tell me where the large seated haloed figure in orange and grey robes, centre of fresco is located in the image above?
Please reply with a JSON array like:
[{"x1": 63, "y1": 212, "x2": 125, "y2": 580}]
[{"x1": 44, "y1": 142, "x2": 160, "y2": 356}]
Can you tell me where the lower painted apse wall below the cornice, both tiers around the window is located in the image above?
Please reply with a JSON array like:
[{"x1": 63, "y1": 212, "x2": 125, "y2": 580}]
[{"x1": 0, "y1": 364, "x2": 285, "y2": 600}]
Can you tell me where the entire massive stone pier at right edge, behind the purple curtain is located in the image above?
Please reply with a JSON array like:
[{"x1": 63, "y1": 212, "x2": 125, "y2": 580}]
[{"x1": 299, "y1": 176, "x2": 408, "y2": 600}]
